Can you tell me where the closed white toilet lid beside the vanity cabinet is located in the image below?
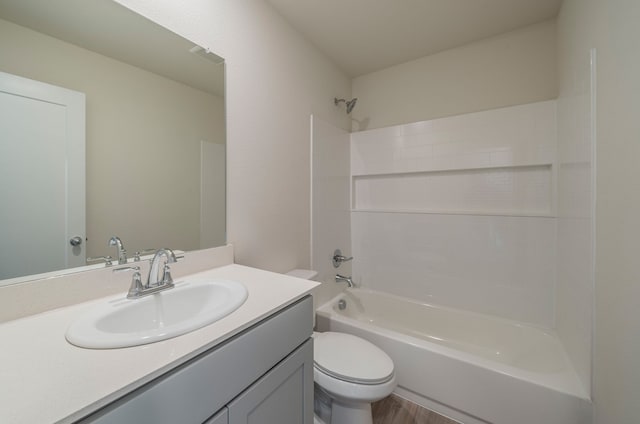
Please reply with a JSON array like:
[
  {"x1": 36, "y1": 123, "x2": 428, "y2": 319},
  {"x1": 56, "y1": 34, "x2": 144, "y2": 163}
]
[{"x1": 313, "y1": 332, "x2": 393, "y2": 384}]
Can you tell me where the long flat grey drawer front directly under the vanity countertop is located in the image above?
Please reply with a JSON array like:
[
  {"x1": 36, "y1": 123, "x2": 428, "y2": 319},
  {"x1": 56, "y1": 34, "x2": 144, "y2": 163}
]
[{"x1": 79, "y1": 296, "x2": 313, "y2": 424}]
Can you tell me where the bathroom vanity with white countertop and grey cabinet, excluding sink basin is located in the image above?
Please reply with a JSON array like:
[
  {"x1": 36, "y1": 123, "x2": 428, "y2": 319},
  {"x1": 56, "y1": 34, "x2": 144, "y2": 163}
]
[{"x1": 0, "y1": 248, "x2": 317, "y2": 424}]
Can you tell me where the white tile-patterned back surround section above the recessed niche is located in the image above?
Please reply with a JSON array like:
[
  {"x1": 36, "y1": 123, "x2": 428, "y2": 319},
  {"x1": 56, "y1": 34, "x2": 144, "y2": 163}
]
[{"x1": 351, "y1": 100, "x2": 556, "y2": 186}]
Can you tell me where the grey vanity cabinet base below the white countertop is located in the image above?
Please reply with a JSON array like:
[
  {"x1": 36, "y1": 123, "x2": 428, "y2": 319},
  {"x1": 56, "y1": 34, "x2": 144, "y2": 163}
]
[{"x1": 78, "y1": 296, "x2": 313, "y2": 424}]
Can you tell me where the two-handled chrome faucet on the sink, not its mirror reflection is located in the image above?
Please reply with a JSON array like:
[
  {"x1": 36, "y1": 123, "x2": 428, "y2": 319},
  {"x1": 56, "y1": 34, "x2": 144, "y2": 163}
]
[{"x1": 113, "y1": 248, "x2": 178, "y2": 299}]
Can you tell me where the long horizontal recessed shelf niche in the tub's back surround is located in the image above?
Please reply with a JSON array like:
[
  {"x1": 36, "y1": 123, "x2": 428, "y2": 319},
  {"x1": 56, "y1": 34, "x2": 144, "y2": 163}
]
[{"x1": 353, "y1": 164, "x2": 552, "y2": 216}]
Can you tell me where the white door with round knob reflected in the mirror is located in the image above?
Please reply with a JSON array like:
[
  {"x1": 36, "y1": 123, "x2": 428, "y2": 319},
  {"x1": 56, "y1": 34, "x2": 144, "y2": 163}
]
[{"x1": 0, "y1": 72, "x2": 85, "y2": 279}]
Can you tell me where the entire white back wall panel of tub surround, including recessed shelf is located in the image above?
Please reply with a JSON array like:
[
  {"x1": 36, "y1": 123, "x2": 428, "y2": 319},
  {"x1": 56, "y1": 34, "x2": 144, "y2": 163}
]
[{"x1": 351, "y1": 101, "x2": 556, "y2": 327}]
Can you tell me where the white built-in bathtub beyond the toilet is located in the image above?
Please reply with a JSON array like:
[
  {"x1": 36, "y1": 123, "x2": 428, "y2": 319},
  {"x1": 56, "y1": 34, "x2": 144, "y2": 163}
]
[{"x1": 316, "y1": 289, "x2": 591, "y2": 424}]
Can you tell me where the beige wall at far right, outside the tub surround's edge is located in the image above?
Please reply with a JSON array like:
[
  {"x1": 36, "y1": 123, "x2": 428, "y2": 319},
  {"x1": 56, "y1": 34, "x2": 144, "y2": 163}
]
[{"x1": 558, "y1": 0, "x2": 640, "y2": 424}]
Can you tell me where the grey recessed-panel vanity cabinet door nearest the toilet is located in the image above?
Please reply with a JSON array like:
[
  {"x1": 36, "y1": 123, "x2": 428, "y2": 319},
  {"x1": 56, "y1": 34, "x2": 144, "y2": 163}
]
[{"x1": 228, "y1": 339, "x2": 313, "y2": 424}]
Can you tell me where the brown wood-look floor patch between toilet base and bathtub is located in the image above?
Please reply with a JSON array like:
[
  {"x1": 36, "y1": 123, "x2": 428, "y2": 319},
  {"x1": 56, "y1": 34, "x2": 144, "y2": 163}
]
[{"x1": 371, "y1": 395, "x2": 459, "y2": 424}]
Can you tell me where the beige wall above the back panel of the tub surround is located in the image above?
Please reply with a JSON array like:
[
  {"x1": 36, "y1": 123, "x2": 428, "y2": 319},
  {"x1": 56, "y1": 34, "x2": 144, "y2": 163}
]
[{"x1": 352, "y1": 20, "x2": 557, "y2": 131}]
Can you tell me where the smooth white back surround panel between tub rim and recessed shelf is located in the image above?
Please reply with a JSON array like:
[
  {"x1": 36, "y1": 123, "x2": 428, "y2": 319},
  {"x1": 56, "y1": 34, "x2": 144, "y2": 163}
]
[{"x1": 352, "y1": 212, "x2": 555, "y2": 327}]
